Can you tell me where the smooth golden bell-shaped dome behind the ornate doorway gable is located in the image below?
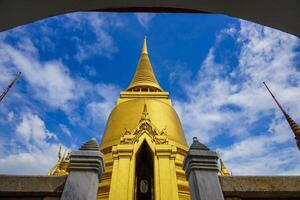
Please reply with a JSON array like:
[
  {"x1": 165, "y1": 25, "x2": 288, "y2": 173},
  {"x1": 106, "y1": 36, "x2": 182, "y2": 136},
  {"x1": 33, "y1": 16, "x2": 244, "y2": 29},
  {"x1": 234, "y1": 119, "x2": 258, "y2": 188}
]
[{"x1": 101, "y1": 98, "x2": 187, "y2": 149}]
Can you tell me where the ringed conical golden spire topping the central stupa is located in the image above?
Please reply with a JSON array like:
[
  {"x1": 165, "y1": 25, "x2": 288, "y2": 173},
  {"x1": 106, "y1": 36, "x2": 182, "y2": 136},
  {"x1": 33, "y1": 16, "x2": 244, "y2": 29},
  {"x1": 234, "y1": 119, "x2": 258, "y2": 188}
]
[{"x1": 126, "y1": 37, "x2": 163, "y2": 91}]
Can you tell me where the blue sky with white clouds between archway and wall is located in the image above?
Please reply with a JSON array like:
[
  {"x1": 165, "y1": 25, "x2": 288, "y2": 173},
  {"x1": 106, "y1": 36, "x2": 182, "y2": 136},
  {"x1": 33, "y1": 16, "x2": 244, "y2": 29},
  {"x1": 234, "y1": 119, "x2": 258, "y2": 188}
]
[{"x1": 0, "y1": 13, "x2": 300, "y2": 175}]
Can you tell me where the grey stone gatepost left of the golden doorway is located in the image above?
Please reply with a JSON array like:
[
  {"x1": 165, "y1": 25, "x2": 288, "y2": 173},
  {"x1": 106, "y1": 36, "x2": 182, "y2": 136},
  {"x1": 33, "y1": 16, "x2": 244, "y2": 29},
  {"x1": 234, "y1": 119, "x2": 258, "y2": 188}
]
[{"x1": 61, "y1": 139, "x2": 104, "y2": 200}]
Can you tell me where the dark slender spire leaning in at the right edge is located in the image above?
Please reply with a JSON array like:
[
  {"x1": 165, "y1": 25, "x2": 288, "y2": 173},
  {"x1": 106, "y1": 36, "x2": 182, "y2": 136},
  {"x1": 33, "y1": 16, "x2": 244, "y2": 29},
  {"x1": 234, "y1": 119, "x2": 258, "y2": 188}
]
[{"x1": 263, "y1": 82, "x2": 300, "y2": 150}]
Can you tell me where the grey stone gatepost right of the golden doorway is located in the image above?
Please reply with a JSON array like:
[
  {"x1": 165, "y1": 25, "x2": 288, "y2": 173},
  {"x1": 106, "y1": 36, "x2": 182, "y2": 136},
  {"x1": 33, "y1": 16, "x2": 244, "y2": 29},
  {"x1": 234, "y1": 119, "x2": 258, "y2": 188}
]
[{"x1": 183, "y1": 137, "x2": 224, "y2": 200}]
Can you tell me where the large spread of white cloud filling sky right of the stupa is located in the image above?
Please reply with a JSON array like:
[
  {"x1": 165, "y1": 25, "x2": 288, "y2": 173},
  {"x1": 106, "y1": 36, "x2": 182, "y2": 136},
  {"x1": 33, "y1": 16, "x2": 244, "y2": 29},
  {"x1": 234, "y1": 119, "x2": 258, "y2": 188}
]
[{"x1": 175, "y1": 21, "x2": 300, "y2": 175}]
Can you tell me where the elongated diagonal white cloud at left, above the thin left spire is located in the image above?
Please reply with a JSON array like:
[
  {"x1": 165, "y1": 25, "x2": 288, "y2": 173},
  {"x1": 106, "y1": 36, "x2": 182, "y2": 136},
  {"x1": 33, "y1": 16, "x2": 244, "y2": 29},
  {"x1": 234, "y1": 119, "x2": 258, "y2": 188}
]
[{"x1": 0, "y1": 39, "x2": 78, "y2": 108}]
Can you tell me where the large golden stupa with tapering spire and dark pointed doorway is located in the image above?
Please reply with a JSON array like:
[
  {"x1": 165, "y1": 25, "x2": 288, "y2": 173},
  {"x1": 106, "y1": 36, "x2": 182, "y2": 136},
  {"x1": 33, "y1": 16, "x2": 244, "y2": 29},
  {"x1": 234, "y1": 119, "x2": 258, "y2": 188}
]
[{"x1": 97, "y1": 38, "x2": 190, "y2": 200}]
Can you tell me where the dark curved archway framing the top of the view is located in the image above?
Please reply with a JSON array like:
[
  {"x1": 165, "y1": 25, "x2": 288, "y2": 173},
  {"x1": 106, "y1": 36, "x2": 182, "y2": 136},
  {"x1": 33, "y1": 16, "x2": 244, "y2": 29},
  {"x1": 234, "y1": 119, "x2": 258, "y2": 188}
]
[{"x1": 0, "y1": 0, "x2": 300, "y2": 37}]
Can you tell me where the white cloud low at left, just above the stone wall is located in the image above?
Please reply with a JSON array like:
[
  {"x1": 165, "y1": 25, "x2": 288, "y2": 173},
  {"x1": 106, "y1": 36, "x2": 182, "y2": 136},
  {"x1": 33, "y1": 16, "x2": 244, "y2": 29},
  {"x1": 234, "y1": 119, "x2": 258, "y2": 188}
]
[{"x1": 0, "y1": 113, "x2": 58, "y2": 175}]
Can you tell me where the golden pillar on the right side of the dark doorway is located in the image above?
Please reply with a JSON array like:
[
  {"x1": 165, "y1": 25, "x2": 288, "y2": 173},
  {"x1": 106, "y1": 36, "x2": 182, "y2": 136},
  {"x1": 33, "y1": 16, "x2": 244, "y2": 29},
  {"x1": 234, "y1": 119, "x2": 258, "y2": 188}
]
[{"x1": 155, "y1": 144, "x2": 178, "y2": 200}]
